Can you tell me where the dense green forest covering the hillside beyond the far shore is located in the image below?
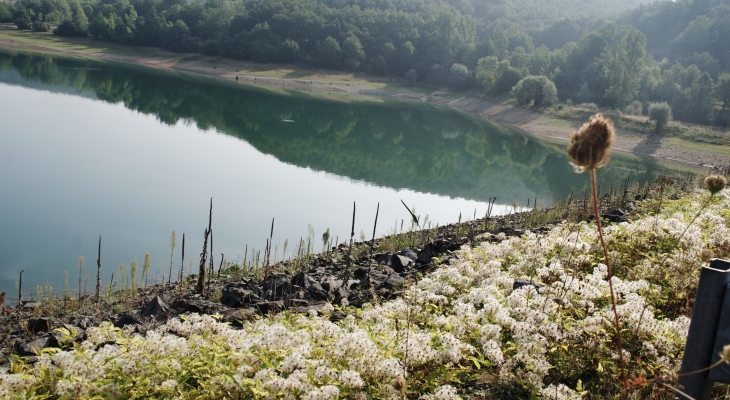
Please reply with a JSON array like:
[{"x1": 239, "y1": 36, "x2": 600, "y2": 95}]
[{"x1": 0, "y1": 0, "x2": 730, "y2": 126}]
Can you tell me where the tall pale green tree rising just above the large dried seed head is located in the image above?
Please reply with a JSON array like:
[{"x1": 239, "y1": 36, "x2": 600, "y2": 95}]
[{"x1": 605, "y1": 27, "x2": 646, "y2": 107}]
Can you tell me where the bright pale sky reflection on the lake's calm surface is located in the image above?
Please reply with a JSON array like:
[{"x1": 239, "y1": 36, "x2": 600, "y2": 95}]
[{"x1": 0, "y1": 84, "x2": 503, "y2": 298}]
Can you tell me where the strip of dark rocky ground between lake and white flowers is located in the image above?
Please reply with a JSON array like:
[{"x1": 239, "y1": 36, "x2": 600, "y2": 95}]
[{"x1": 0, "y1": 200, "x2": 628, "y2": 369}]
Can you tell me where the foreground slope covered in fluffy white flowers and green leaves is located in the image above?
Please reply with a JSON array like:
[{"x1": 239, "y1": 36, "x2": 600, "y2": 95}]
[{"x1": 0, "y1": 188, "x2": 730, "y2": 399}]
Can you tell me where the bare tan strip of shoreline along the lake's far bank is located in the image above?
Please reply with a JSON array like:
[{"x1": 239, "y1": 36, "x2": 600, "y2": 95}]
[{"x1": 0, "y1": 37, "x2": 726, "y2": 168}]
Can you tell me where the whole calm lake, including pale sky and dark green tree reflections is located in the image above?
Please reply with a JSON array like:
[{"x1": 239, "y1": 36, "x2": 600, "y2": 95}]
[{"x1": 0, "y1": 50, "x2": 677, "y2": 299}]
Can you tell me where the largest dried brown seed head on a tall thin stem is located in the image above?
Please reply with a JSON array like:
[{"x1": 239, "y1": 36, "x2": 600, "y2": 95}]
[{"x1": 568, "y1": 114, "x2": 614, "y2": 172}]
